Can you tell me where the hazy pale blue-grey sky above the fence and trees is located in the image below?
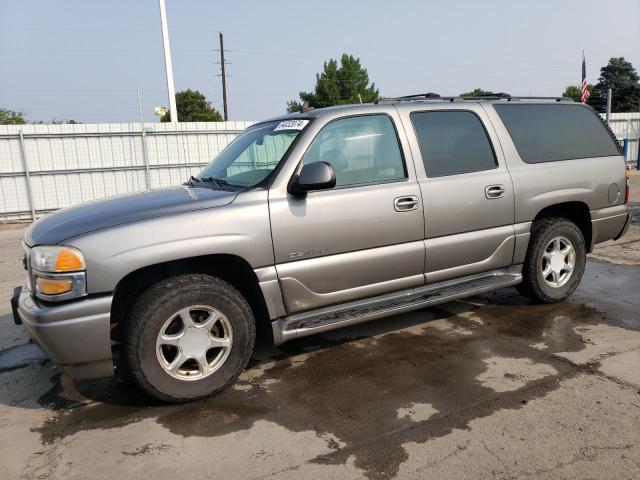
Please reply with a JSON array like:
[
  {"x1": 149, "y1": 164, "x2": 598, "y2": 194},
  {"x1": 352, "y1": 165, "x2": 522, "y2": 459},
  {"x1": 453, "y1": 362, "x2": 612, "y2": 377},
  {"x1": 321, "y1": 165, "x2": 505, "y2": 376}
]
[{"x1": 0, "y1": 0, "x2": 640, "y2": 123}]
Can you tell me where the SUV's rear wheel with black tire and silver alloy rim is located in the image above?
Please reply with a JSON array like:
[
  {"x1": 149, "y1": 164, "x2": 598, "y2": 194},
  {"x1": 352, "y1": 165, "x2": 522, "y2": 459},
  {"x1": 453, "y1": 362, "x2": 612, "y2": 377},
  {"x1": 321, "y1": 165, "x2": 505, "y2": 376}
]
[{"x1": 516, "y1": 217, "x2": 587, "y2": 303}]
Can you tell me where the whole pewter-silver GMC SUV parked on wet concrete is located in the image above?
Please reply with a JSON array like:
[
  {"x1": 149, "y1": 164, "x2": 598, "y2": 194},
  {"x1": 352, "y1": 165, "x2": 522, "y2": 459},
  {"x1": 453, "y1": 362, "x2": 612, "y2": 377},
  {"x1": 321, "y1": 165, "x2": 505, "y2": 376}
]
[{"x1": 12, "y1": 94, "x2": 630, "y2": 402}]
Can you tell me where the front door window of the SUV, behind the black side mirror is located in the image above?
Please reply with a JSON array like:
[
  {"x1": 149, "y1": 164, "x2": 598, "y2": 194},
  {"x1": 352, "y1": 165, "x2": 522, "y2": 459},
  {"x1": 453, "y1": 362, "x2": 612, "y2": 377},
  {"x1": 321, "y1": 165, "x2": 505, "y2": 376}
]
[{"x1": 303, "y1": 115, "x2": 406, "y2": 186}]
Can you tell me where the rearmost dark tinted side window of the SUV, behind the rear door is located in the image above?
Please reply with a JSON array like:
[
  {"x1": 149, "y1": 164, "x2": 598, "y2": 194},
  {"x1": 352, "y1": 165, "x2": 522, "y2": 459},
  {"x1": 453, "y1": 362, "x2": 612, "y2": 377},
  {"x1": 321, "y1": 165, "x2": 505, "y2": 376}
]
[{"x1": 494, "y1": 104, "x2": 619, "y2": 163}]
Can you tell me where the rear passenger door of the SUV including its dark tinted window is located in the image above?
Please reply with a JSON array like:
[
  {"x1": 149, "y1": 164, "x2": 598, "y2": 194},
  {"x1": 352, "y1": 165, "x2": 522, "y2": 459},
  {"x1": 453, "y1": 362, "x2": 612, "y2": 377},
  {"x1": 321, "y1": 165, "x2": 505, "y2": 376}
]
[{"x1": 400, "y1": 104, "x2": 515, "y2": 283}]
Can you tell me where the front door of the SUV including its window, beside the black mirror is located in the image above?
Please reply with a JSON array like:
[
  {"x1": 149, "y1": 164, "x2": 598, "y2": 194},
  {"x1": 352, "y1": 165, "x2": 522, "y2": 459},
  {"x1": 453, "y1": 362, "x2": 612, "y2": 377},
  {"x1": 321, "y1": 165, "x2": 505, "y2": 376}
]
[{"x1": 269, "y1": 113, "x2": 424, "y2": 313}]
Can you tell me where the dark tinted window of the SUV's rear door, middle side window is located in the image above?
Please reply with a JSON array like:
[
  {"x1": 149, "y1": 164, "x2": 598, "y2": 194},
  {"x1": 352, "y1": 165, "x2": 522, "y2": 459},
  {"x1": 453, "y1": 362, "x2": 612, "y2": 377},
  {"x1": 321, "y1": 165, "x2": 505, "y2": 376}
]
[{"x1": 411, "y1": 111, "x2": 496, "y2": 177}]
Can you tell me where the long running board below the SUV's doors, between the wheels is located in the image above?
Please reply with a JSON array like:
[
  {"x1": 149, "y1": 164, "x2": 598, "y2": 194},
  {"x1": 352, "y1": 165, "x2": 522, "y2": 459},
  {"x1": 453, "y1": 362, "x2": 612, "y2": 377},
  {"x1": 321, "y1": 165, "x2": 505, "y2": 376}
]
[{"x1": 272, "y1": 265, "x2": 522, "y2": 345}]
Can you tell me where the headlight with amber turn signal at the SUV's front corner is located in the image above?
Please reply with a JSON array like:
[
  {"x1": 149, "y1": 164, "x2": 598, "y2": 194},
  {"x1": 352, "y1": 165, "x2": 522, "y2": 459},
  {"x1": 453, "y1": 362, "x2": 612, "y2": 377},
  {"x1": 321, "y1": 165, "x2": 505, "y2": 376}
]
[{"x1": 29, "y1": 246, "x2": 87, "y2": 301}]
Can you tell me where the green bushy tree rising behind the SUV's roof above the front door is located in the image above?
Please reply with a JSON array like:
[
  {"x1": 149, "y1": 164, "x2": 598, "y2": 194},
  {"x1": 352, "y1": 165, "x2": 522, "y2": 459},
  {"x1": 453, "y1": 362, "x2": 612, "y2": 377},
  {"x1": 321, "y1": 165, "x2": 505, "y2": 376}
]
[{"x1": 287, "y1": 53, "x2": 380, "y2": 112}]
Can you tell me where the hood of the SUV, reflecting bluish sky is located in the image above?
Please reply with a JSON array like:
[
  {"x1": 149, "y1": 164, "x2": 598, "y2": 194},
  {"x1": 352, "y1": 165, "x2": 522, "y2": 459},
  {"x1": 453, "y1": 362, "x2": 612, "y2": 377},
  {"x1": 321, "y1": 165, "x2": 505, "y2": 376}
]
[{"x1": 24, "y1": 186, "x2": 238, "y2": 246}]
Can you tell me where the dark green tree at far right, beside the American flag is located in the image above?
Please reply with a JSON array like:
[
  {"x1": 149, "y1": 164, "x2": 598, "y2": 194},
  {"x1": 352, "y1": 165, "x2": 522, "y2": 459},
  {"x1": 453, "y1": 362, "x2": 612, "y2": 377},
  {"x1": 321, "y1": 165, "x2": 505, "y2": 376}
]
[{"x1": 589, "y1": 57, "x2": 640, "y2": 112}]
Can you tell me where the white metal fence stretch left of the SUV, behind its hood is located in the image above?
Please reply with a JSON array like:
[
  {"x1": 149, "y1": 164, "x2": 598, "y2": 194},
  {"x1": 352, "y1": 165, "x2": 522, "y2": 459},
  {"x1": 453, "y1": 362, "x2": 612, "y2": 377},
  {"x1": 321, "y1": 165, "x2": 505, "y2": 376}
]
[{"x1": 0, "y1": 122, "x2": 253, "y2": 220}]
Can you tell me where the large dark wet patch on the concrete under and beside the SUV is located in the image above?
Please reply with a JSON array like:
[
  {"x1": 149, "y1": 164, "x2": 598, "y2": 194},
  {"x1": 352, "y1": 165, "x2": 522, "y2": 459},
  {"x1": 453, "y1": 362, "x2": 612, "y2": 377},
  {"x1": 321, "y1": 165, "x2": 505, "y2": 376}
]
[{"x1": 17, "y1": 262, "x2": 640, "y2": 479}]
